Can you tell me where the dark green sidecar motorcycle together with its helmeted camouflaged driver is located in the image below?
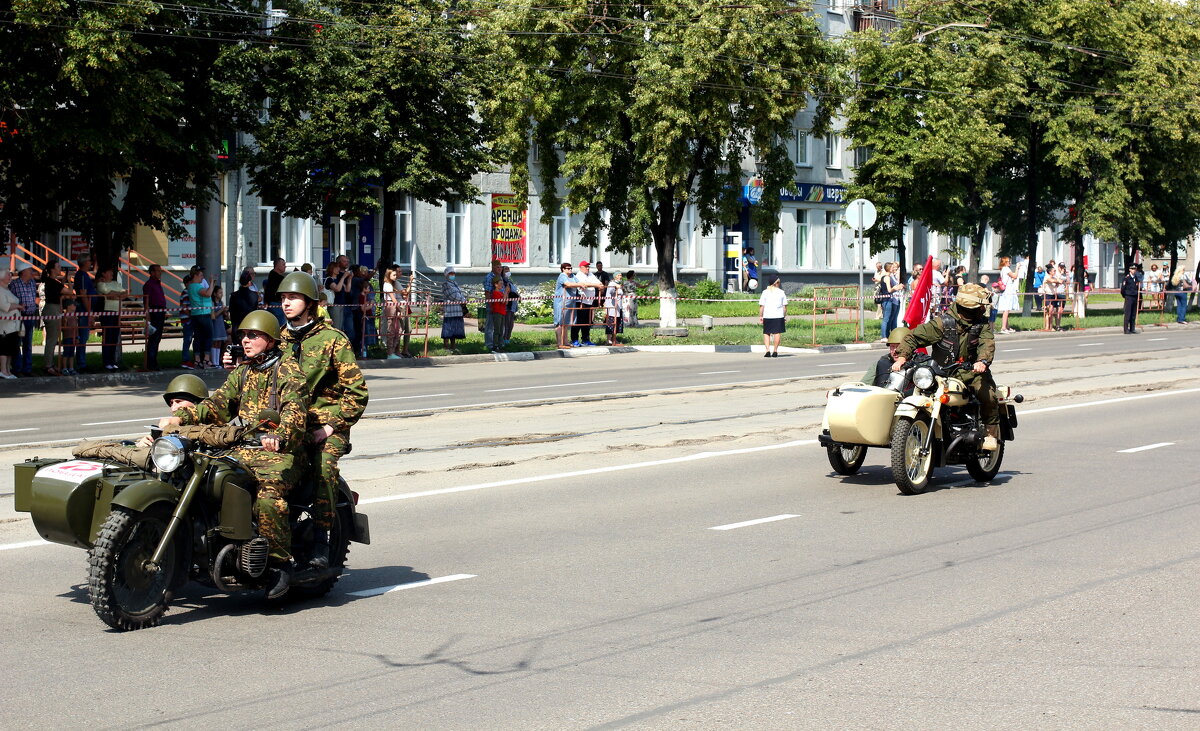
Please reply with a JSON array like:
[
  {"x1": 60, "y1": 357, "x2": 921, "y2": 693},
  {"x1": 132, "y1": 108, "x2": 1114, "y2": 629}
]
[{"x1": 14, "y1": 312, "x2": 370, "y2": 630}]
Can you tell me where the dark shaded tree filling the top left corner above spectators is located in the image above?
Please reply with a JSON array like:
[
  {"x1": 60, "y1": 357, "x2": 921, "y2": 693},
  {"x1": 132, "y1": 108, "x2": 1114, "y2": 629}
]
[{"x1": 0, "y1": 0, "x2": 259, "y2": 266}]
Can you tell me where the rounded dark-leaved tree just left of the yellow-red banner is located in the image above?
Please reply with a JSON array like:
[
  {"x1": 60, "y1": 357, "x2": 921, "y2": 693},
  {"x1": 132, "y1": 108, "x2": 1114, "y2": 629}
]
[{"x1": 241, "y1": 0, "x2": 491, "y2": 274}]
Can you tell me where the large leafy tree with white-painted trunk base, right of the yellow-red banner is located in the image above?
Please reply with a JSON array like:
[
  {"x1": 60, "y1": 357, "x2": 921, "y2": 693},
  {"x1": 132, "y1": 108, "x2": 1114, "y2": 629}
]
[{"x1": 480, "y1": 0, "x2": 841, "y2": 324}]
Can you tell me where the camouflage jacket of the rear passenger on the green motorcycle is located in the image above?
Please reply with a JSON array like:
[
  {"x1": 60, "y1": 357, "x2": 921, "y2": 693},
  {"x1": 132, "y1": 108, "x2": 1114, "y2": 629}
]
[{"x1": 280, "y1": 317, "x2": 367, "y2": 432}]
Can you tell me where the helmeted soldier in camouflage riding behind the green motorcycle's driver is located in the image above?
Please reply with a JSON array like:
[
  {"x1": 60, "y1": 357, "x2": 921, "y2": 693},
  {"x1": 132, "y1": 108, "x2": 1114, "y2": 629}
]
[{"x1": 278, "y1": 271, "x2": 367, "y2": 568}]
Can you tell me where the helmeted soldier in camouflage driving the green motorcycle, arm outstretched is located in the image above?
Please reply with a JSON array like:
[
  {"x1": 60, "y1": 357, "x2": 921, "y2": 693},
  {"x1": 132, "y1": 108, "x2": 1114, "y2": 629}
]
[{"x1": 160, "y1": 310, "x2": 308, "y2": 599}]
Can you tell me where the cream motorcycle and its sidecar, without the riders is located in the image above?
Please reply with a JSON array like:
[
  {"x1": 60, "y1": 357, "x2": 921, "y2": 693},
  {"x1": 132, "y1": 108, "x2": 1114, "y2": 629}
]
[{"x1": 818, "y1": 356, "x2": 1024, "y2": 495}]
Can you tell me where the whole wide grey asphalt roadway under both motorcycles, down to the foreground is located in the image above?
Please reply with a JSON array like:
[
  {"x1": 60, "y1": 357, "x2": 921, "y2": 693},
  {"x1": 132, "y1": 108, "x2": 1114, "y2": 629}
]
[{"x1": 0, "y1": 330, "x2": 1200, "y2": 729}]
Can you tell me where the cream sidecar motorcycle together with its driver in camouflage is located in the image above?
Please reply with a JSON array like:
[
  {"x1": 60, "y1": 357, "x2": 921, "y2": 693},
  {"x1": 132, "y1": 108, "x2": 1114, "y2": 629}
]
[{"x1": 820, "y1": 284, "x2": 1022, "y2": 495}]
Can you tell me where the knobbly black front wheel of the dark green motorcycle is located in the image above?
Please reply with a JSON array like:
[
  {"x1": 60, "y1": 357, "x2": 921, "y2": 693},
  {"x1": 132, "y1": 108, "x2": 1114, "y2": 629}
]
[{"x1": 88, "y1": 508, "x2": 178, "y2": 631}]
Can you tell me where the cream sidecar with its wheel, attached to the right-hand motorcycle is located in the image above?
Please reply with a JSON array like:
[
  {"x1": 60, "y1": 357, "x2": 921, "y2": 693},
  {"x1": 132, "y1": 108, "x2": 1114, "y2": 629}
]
[{"x1": 817, "y1": 382, "x2": 901, "y2": 475}]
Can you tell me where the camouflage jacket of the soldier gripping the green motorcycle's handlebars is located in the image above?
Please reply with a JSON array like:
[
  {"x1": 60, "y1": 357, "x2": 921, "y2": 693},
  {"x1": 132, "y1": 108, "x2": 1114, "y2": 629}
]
[{"x1": 175, "y1": 356, "x2": 308, "y2": 453}]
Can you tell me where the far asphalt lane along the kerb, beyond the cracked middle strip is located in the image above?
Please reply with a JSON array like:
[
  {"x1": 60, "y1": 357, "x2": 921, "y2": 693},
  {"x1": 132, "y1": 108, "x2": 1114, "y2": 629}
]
[{"x1": 0, "y1": 328, "x2": 1200, "y2": 450}]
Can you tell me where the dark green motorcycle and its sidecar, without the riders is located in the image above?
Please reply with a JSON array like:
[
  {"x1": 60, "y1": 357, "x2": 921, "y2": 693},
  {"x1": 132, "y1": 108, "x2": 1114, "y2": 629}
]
[{"x1": 14, "y1": 411, "x2": 371, "y2": 630}]
